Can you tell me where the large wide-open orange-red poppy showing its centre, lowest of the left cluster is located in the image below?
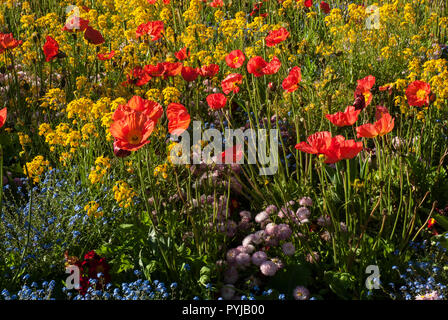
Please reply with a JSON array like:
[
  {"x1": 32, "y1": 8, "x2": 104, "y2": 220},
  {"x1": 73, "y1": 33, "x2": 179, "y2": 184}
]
[{"x1": 110, "y1": 112, "x2": 155, "y2": 151}]
